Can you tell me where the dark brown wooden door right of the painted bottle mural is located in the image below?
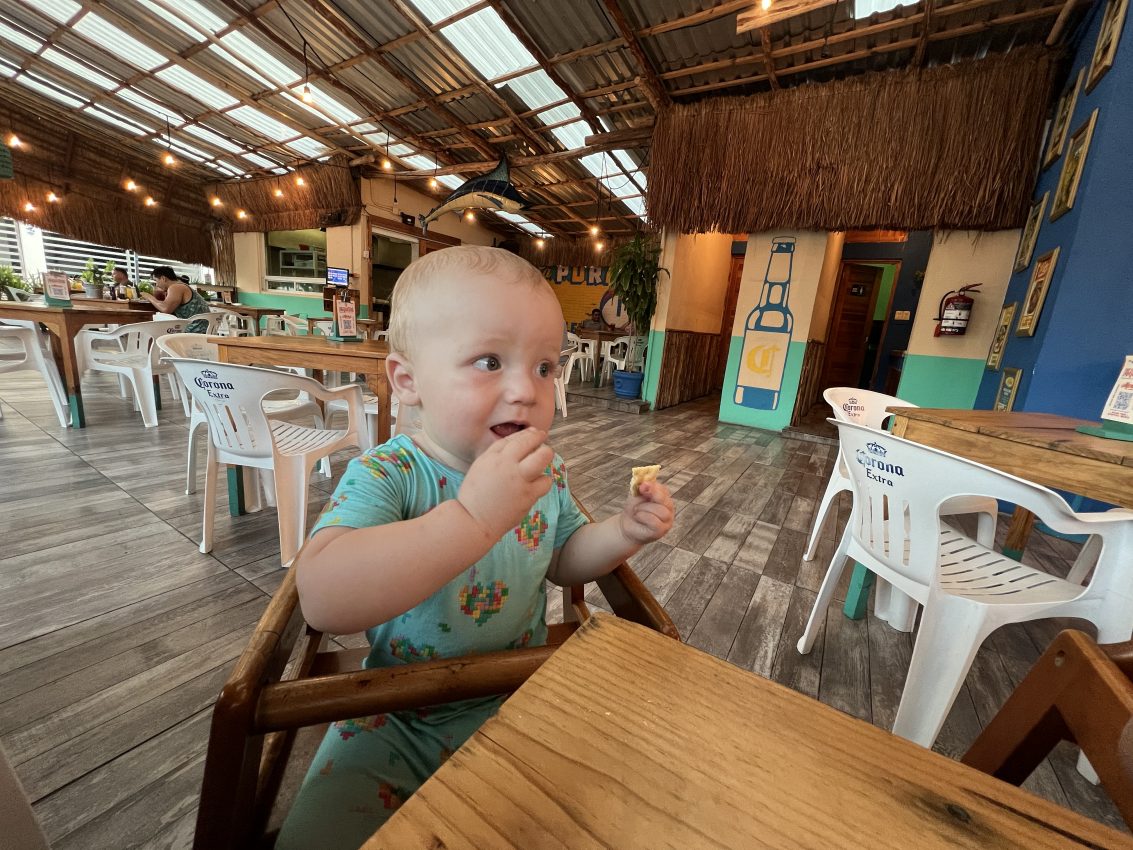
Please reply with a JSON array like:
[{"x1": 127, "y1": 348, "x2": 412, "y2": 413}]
[{"x1": 820, "y1": 263, "x2": 881, "y2": 390}]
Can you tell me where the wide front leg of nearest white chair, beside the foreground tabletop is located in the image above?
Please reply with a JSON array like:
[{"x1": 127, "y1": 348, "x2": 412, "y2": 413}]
[{"x1": 893, "y1": 598, "x2": 991, "y2": 747}]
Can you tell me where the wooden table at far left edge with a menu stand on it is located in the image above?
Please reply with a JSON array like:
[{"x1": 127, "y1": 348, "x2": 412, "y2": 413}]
[{"x1": 0, "y1": 298, "x2": 154, "y2": 428}]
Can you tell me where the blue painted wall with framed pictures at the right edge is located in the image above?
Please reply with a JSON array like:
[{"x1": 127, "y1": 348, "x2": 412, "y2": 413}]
[{"x1": 976, "y1": 0, "x2": 1133, "y2": 418}]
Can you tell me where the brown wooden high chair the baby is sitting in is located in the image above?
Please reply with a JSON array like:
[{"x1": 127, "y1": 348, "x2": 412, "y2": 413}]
[{"x1": 193, "y1": 505, "x2": 680, "y2": 850}]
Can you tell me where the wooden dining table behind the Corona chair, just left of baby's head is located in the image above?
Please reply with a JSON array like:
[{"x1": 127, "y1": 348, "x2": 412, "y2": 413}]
[{"x1": 208, "y1": 335, "x2": 391, "y2": 515}]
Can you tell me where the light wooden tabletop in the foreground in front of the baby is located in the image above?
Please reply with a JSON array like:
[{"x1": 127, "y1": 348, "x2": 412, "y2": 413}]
[{"x1": 363, "y1": 613, "x2": 1133, "y2": 850}]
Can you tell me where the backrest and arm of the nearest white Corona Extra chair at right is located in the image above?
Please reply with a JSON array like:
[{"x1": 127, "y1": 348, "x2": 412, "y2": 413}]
[{"x1": 834, "y1": 422, "x2": 1110, "y2": 593}]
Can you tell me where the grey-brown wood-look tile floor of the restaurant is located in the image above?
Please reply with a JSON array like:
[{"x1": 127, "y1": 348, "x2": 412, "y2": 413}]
[{"x1": 0, "y1": 373, "x2": 1121, "y2": 850}]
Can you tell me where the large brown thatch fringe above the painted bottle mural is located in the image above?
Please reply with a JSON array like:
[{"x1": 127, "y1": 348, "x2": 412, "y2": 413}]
[{"x1": 648, "y1": 48, "x2": 1057, "y2": 233}]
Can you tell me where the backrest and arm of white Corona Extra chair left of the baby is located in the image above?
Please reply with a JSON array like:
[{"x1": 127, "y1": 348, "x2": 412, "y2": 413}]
[{"x1": 170, "y1": 357, "x2": 320, "y2": 462}]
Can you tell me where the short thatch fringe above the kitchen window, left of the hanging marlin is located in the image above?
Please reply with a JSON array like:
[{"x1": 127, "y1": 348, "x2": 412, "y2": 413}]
[{"x1": 205, "y1": 156, "x2": 361, "y2": 232}]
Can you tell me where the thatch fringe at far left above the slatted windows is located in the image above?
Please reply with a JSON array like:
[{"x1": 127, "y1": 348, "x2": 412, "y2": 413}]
[{"x1": 0, "y1": 173, "x2": 212, "y2": 265}]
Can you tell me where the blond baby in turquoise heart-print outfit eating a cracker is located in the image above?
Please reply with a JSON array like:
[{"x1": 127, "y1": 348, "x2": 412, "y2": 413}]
[{"x1": 276, "y1": 246, "x2": 673, "y2": 850}]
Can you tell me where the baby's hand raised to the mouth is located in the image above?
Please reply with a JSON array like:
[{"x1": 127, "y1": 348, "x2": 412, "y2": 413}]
[{"x1": 457, "y1": 428, "x2": 554, "y2": 539}]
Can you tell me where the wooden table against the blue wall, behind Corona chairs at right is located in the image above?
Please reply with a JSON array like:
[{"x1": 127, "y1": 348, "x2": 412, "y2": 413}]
[{"x1": 844, "y1": 407, "x2": 1133, "y2": 617}]
